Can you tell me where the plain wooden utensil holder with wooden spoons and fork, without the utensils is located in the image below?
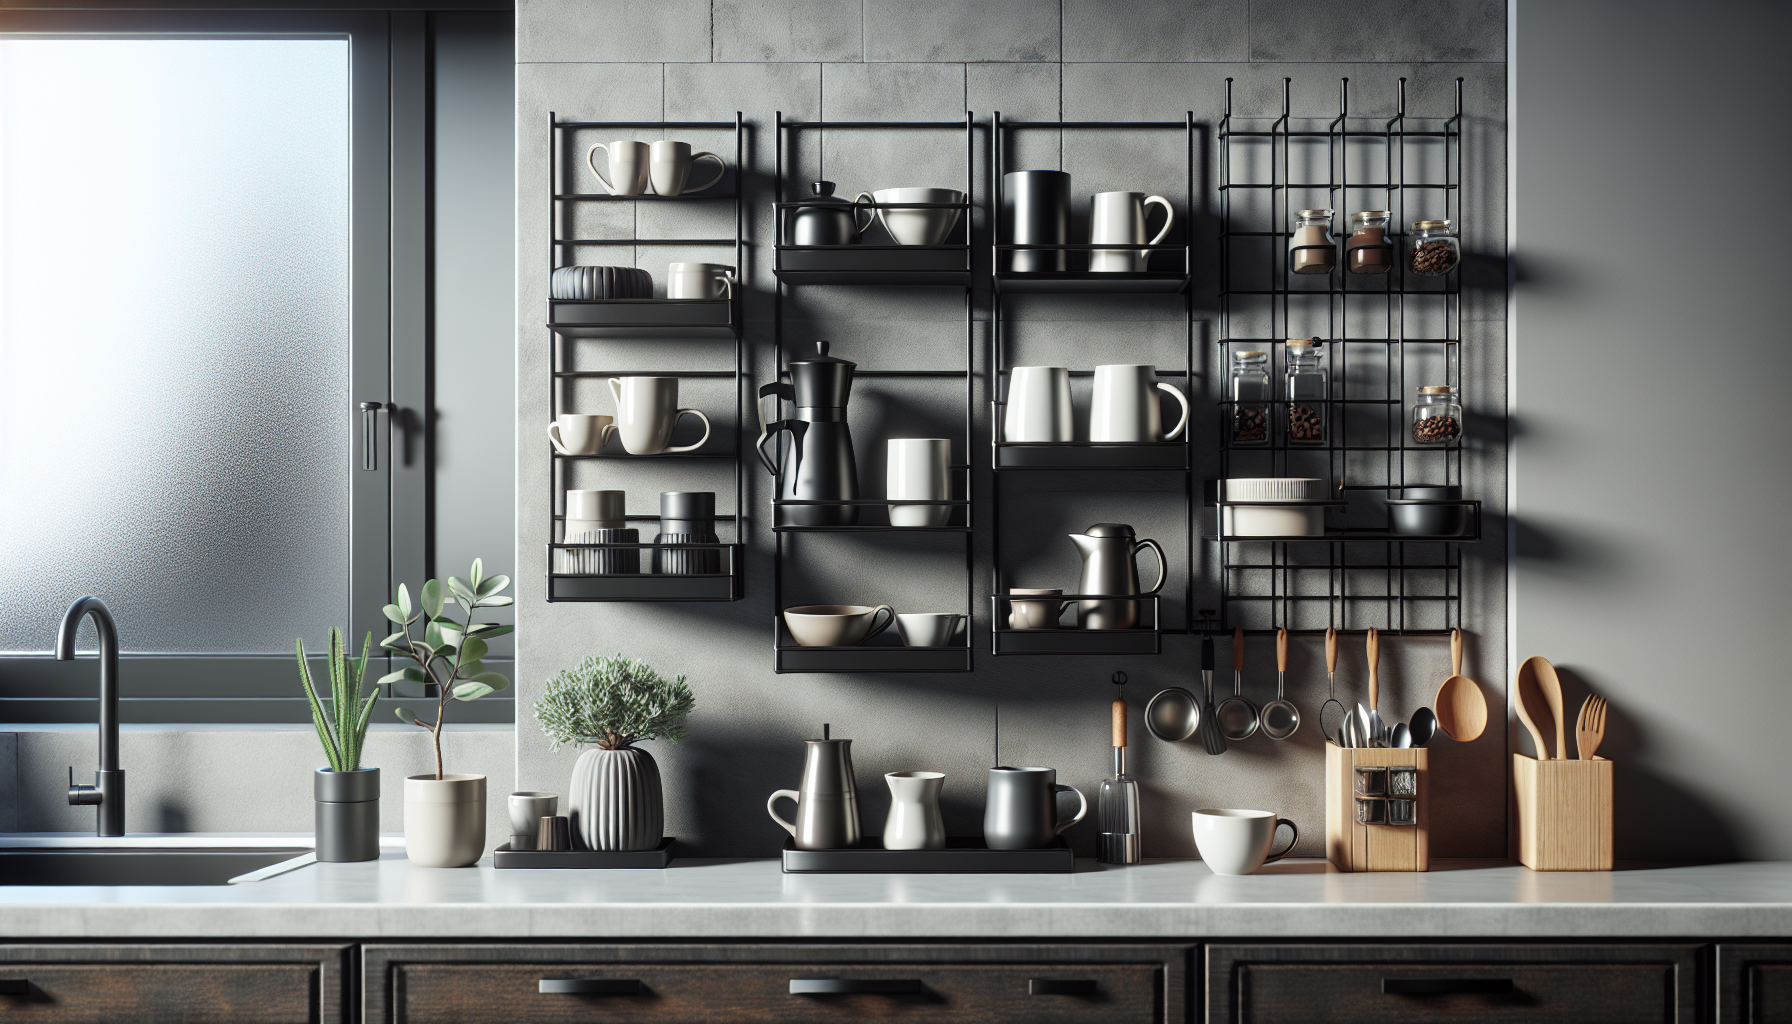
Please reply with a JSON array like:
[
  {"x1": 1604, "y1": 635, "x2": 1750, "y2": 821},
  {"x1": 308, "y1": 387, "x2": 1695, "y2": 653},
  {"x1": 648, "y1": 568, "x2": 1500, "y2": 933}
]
[{"x1": 1512, "y1": 753, "x2": 1611, "y2": 872}]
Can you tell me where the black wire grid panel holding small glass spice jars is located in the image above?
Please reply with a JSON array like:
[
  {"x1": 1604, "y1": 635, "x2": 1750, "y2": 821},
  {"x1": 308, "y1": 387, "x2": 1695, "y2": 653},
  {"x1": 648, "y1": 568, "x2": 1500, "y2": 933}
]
[{"x1": 1206, "y1": 79, "x2": 1480, "y2": 635}]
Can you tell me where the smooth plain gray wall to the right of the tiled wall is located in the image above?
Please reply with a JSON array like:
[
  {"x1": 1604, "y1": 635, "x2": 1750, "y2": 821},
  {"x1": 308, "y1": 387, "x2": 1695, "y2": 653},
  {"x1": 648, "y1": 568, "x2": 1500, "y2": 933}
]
[{"x1": 1512, "y1": 0, "x2": 1792, "y2": 859}]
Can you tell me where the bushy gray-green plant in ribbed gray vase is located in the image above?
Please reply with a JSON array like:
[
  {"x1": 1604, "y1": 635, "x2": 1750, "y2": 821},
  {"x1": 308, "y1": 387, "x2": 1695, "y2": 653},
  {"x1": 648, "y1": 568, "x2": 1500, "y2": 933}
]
[{"x1": 534, "y1": 655, "x2": 695, "y2": 852}]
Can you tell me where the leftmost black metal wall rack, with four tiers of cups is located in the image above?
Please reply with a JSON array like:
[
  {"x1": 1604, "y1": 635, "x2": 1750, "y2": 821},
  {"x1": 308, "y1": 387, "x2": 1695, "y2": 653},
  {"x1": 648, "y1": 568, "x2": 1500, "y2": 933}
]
[{"x1": 545, "y1": 111, "x2": 745, "y2": 601}]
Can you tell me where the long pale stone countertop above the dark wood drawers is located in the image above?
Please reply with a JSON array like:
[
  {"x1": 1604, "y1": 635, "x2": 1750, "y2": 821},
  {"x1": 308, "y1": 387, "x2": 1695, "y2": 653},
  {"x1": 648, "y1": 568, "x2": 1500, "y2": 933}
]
[{"x1": 0, "y1": 852, "x2": 1792, "y2": 940}]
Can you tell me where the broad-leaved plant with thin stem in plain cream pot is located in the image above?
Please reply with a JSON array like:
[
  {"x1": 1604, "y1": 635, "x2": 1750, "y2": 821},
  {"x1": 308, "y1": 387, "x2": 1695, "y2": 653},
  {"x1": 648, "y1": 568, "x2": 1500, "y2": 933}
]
[{"x1": 380, "y1": 558, "x2": 513, "y2": 868}]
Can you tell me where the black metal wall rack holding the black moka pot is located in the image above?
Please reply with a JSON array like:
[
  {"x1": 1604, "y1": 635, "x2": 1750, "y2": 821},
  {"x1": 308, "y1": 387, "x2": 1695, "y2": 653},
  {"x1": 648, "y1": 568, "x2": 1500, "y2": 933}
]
[{"x1": 758, "y1": 111, "x2": 977, "y2": 673}]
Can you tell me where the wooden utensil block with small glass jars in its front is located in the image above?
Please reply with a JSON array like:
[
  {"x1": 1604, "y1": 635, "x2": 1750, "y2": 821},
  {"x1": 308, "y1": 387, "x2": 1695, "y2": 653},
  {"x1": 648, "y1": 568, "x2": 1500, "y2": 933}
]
[{"x1": 1326, "y1": 742, "x2": 1432, "y2": 872}]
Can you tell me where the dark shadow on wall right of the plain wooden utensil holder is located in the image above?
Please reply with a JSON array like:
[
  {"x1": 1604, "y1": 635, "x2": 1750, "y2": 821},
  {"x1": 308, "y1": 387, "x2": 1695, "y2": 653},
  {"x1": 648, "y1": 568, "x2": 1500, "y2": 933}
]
[{"x1": 1555, "y1": 665, "x2": 1744, "y2": 863}]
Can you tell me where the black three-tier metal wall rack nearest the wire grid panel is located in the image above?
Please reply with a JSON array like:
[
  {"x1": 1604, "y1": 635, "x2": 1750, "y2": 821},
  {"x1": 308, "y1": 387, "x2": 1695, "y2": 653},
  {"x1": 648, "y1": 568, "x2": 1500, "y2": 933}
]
[{"x1": 989, "y1": 111, "x2": 1195, "y2": 655}]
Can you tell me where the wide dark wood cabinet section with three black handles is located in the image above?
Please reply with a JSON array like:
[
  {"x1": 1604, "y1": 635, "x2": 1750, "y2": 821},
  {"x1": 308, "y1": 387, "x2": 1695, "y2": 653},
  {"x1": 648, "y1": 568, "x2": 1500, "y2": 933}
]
[{"x1": 362, "y1": 943, "x2": 1192, "y2": 1024}]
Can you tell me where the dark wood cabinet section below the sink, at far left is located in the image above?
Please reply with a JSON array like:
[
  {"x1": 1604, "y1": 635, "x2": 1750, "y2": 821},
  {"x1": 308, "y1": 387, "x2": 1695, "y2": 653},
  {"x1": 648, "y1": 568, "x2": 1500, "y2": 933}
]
[{"x1": 0, "y1": 943, "x2": 349, "y2": 1024}]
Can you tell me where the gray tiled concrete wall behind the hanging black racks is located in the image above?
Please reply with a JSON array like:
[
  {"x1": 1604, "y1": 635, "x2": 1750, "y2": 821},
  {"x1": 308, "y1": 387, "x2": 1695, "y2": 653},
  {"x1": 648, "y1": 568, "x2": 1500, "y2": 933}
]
[{"x1": 516, "y1": 0, "x2": 1507, "y2": 857}]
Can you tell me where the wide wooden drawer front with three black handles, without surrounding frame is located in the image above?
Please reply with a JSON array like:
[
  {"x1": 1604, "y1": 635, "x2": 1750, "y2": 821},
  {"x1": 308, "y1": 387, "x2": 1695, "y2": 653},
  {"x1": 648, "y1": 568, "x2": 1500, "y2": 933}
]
[{"x1": 394, "y1": 963, "x2": 1161, "y2": 1024}]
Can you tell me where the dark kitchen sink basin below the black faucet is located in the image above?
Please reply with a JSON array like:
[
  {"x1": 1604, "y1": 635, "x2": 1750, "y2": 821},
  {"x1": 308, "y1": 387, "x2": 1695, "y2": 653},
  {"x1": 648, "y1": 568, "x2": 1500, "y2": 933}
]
[{"x1": 0, "y1": 846, "x2": 312, "y2": 886}]
